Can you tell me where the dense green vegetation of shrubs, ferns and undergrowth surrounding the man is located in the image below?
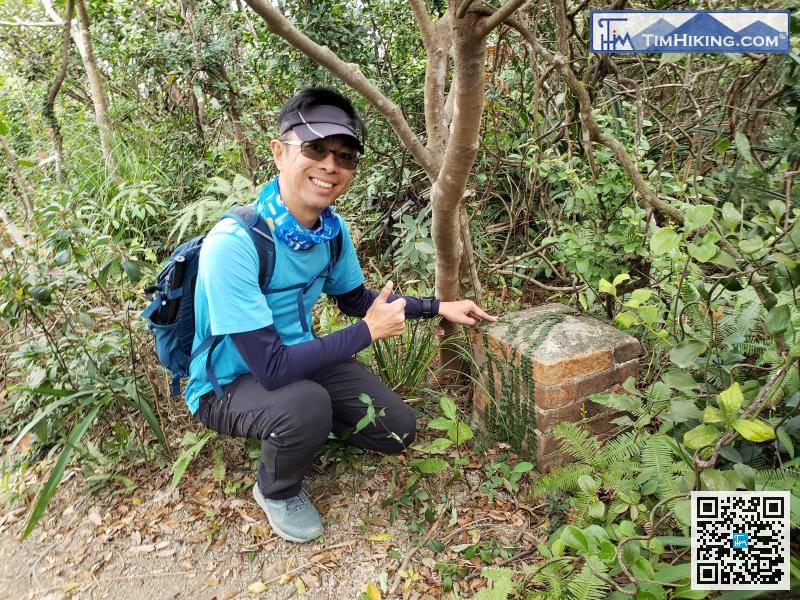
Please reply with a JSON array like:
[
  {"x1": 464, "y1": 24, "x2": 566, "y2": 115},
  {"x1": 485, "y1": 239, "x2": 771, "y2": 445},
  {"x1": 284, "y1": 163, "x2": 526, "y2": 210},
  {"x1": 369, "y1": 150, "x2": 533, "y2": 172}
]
[{"x1": 0, "y1": 0, "x2": 800, "y2": 598}]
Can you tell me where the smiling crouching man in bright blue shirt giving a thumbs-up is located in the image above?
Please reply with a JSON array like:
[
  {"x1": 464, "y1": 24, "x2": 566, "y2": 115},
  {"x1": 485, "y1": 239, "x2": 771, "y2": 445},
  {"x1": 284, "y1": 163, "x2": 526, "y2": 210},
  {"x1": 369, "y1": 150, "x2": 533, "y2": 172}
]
[{"x1": 186, "y1": 88, "x2": 496, "y2": 542}]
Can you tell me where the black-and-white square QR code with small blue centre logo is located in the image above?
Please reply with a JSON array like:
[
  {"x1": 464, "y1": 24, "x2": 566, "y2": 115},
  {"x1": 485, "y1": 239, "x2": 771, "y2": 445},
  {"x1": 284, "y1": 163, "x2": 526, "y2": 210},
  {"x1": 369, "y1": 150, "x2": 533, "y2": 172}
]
[{"x1": 692, "y1": 492, "x2": 789, "y2": 590}]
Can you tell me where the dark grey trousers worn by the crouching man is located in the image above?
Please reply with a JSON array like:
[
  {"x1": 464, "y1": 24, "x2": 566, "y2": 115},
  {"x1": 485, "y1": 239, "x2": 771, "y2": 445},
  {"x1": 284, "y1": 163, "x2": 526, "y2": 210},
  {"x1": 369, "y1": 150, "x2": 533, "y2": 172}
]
[{"x1": 195, "y1": 358, "x2": 416, "y2": 500}]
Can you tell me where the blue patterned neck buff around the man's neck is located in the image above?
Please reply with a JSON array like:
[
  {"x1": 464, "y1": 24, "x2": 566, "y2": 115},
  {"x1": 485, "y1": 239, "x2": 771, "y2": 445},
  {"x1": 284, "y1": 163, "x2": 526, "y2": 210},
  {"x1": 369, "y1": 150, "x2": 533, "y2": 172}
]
[{"x1": 255, "y1": 176, "x2": 340, "y2": 250}]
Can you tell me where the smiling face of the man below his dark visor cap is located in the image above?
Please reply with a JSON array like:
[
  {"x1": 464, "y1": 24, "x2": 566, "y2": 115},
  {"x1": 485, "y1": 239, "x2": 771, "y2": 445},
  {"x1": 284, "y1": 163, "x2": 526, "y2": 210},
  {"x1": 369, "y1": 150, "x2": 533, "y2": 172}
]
[{"x1": 270, "y1": 131, "x2": 356, "y2": 213}]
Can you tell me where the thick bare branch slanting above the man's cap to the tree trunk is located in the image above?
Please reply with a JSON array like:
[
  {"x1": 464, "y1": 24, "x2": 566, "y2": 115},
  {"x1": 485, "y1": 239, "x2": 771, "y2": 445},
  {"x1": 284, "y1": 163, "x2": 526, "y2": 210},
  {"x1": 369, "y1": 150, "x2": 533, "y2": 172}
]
[{"x1": 246, "y1": 0, "x2": 438, "y2": 181}]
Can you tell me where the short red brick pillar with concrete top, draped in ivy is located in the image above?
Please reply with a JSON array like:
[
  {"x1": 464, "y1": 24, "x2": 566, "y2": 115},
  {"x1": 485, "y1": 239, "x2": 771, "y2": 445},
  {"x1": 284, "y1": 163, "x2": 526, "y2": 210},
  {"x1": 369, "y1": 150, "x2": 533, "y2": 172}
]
[{"x1": 473, "y1": 303, "x2": 639, "y2": 471}]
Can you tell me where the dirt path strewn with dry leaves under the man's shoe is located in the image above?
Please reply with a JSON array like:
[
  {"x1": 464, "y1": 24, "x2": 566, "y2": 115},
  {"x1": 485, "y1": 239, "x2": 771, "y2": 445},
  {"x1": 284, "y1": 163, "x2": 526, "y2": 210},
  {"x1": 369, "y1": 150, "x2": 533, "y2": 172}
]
[{"x1": 0, "y1": 428, "x2": 537, "y2": 600}]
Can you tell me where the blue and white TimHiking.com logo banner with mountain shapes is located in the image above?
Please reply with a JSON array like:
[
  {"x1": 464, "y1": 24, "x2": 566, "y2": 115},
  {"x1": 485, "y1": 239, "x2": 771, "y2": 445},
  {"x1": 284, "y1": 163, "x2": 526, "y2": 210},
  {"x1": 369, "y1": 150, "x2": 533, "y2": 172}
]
[{"x1": 590, "y1": 10, "x2": 789, "y2": 54}]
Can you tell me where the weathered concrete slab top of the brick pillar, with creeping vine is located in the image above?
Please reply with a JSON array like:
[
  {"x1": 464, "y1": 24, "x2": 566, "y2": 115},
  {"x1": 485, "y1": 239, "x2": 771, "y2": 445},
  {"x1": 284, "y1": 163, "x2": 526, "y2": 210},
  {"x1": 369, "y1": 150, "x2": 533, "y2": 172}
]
[{"x1": 476, "y1": 302, "x2": 636, "y2": 364}]
